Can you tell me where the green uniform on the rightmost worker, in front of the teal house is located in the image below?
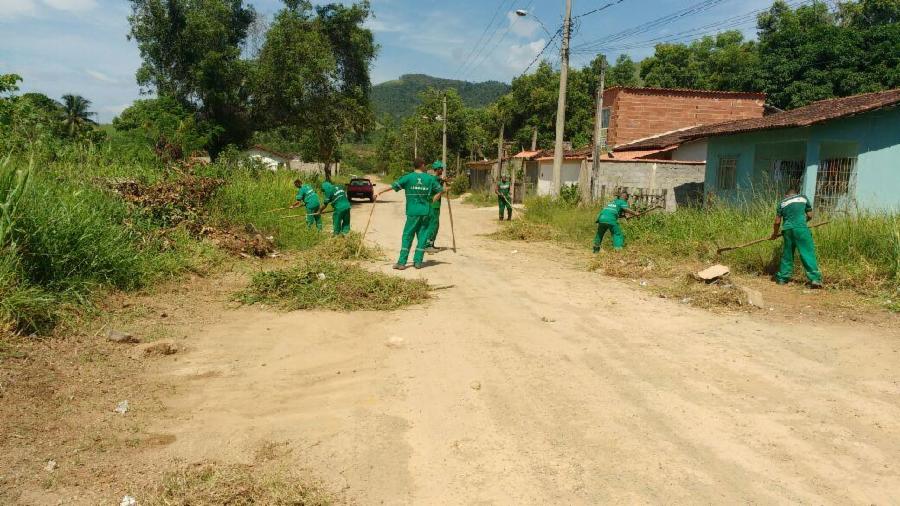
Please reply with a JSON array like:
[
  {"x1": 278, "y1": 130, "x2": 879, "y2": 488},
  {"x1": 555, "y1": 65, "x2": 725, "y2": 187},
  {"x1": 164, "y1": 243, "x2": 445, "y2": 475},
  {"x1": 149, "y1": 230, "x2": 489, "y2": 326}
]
[{"x1": 775, "y1": 195, "x2": 822, "y2": 283}]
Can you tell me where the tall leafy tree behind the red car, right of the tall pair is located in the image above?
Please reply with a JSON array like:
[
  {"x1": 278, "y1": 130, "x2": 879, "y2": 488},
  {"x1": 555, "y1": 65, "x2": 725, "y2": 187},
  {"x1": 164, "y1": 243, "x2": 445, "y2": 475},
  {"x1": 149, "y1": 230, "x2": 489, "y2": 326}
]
[{"x1": 254, "y1": 0, "x2": 377, "y2": 179}]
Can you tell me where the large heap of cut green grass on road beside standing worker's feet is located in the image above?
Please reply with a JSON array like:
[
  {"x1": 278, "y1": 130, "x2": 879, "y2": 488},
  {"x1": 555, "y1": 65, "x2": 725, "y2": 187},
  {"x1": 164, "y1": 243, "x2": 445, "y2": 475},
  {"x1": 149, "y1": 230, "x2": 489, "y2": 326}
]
[{"x1": 238, "y1": 236, "x2": 431, "y2": 311}]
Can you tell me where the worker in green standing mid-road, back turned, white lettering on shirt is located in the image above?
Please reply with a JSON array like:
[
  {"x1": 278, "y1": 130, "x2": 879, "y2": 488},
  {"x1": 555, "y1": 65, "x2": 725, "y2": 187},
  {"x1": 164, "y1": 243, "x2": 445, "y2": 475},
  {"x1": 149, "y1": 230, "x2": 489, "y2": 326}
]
[{"x1": 375, "y1": 160, "x2": 444, "y2": 271}]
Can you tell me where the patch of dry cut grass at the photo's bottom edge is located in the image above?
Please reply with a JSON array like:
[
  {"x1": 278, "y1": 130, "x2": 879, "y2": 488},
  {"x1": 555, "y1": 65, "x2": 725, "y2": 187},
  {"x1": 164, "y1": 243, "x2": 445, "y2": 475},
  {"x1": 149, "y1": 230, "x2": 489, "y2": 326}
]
[{"x1": 149, "y1": 462, "x2": 334, "y2": 506}]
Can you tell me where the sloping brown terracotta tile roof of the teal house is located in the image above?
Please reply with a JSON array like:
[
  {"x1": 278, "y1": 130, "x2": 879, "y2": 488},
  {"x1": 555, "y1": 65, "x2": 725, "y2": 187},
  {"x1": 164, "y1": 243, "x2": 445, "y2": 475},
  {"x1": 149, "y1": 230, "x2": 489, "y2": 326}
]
[{"x1": 614, "y1": 88, "x2": 900, "y2": 151}]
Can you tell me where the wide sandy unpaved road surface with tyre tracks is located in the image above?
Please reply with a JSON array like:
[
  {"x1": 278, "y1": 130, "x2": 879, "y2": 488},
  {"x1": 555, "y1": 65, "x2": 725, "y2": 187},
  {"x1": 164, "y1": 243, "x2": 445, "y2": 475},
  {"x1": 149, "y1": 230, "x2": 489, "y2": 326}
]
[{"x1": 148, "y1": 194, "x2": 900, "y2": 504}]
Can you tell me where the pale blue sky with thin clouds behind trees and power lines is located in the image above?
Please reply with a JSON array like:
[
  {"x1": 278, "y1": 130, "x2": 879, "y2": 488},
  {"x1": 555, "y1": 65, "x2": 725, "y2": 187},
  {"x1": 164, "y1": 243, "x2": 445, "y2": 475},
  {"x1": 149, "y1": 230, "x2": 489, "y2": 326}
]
[{"x1": 0, "y1": 0, "x2": 772, "y2": 121}]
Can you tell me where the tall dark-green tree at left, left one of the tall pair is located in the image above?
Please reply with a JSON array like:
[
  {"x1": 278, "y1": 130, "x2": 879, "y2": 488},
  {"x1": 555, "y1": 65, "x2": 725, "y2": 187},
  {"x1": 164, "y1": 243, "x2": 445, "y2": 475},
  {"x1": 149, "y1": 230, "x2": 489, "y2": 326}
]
[{"x1": 128, "y1": 0, "x2": 256, "y2": 156}]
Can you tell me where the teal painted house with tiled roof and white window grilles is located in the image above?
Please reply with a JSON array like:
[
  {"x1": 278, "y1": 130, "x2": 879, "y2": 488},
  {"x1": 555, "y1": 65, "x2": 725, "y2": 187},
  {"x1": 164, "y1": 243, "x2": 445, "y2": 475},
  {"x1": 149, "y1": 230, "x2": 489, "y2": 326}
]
[{"x1": 612, "y1": 89, "x2": 900, "y2": 211}]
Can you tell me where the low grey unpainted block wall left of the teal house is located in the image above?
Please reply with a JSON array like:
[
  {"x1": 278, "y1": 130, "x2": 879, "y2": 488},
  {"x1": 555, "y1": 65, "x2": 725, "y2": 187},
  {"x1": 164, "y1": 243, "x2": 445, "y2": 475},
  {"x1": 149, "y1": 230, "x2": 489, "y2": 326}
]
[{"x1": 592, "y1": 160, "x2": 706, "y2": 211}]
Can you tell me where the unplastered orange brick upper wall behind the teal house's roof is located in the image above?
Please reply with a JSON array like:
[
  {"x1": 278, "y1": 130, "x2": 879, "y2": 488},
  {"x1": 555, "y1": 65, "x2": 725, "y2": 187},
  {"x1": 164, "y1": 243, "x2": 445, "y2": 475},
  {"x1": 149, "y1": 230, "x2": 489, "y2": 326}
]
[{"x1": 603, "y1": 88, "x2": 765, "y2": 147}]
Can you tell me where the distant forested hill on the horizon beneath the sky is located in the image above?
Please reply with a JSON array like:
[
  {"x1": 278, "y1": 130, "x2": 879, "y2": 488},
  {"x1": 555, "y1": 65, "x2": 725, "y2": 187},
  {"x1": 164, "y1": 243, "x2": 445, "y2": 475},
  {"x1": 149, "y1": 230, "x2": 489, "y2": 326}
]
[{"x1": 372, "y1": 74, "x2": 509, "y2": 118}]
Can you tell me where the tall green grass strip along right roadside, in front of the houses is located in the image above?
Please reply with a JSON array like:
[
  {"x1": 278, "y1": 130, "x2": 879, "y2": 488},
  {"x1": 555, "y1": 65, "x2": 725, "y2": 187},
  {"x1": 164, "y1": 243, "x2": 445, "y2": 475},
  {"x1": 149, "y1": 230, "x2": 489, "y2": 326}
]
[{"x1": 497, "y1": 198, "x2": 900, "y2": 301}]
